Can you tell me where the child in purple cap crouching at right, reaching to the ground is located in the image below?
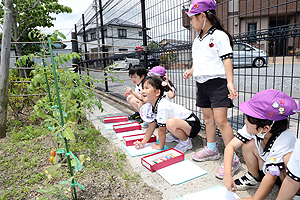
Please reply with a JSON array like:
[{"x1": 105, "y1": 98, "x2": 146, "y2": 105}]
[{"x1": 223, "y1": 89, "x2": 297, "y2": 199}]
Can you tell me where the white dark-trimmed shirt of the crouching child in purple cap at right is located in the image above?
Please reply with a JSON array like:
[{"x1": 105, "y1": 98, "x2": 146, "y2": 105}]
[{"x1": 235, "y1": 125, "x2": 297, "y2": 174}]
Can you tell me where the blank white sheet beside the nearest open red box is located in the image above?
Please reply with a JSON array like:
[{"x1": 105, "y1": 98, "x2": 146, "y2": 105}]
[{"x1": 156, "y1": 160, "x2": 207, "y2": 186}]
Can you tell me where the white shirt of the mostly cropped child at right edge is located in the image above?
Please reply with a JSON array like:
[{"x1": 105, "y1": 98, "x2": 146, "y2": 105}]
[{"x1": 286, "y1": 140, "x2": 300, "y2": 182}]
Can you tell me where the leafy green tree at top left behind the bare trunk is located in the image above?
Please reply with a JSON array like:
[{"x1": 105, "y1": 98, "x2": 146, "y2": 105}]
[{"x1": 0, "y1": 0, "x2": 72, "y2": 77}]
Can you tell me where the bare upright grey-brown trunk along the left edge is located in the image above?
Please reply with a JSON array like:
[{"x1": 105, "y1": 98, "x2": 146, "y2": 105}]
[{"x1": 0, "y1": 0, "x2": 13, "y2": 138}]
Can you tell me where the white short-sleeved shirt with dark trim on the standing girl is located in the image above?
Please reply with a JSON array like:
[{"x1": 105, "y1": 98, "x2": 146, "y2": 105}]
[{"x1": 192, "y1": 27, "x2": 233, "y2": 83}]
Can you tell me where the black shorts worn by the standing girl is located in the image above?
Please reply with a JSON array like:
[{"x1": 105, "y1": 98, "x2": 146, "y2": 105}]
[{"x1": 196, "y1": 78, "x2": 233, "y2": 108}]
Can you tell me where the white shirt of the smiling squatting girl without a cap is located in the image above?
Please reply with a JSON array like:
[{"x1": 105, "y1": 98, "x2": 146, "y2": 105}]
[{"x1": 153, "y1": 98, "x2": 192, "y2": 127}]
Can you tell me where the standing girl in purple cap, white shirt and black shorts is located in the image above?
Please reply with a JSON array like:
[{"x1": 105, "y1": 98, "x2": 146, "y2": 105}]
[{"x1": 183, "y1": 0, "x2": 240, "y2": 179}]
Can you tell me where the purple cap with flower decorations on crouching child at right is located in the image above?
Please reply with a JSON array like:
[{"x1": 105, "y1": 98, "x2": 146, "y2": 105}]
[{"x1": 240, "y1": 89, "x2": 297, "y2": 121}]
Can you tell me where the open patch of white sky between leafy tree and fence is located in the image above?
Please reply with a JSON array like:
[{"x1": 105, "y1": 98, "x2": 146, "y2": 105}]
[{"x1": 41, "y1": 0, "x2": 93, "y2": 49}]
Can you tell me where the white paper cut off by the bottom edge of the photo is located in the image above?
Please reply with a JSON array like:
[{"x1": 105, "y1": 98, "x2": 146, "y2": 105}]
[{"x1": 183, "y1": 186, "x2": 240, "y2": 200}]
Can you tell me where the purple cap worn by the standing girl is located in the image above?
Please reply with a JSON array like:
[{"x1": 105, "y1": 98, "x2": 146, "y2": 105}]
[{"x1": 185, "y1": 0, "x2": 217, "y2": 17}]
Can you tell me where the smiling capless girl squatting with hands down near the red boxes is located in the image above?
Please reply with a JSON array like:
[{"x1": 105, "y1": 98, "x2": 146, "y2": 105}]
[{"x1": 134, "y1": 76, "x2": 200, "y2": 153}]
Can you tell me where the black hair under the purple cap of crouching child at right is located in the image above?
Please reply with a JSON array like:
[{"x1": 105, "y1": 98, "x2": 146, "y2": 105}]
[{"x1": 246, "y1": 115, "x2": 289, "y2": 135}]
